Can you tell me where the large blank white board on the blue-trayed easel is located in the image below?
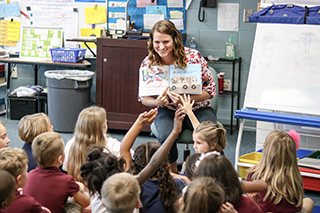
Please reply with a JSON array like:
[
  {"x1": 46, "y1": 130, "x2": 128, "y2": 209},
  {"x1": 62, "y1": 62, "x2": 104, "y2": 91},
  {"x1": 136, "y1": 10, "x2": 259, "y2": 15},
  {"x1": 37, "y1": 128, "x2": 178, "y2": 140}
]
[{"x1": 244, "y1": 23, "x2": 320, "y2": 115}]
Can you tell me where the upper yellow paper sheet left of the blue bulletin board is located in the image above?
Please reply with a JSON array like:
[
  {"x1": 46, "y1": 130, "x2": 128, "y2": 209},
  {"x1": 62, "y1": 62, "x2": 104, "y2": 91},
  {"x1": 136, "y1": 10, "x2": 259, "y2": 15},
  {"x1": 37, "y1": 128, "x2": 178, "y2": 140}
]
[{"x1": 84, "y1": 7, "x2": 107, "y2": 24}]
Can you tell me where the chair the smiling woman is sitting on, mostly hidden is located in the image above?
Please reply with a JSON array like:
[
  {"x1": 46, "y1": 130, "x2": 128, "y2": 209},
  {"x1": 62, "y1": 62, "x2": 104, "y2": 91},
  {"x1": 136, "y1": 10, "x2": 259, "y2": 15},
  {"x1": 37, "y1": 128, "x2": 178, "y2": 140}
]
[{"x1": 150, "y1": 66, "x2": 223, "y2": 161}]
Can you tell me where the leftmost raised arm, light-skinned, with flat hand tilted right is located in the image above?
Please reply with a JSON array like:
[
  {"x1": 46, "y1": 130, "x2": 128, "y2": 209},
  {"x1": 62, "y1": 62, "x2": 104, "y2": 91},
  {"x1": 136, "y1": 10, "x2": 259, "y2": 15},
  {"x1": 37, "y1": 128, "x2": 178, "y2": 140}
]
[{"x1": 120, "y1": 109, "x2": 158, "y2": 171}]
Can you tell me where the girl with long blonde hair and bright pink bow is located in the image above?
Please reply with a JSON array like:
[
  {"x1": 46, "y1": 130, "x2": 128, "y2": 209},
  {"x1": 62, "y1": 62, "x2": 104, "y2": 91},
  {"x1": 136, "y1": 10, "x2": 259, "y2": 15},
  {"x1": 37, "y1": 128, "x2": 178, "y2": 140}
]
[{"x1": 247, "y1": 130, "x2": 314, "y2": 213}]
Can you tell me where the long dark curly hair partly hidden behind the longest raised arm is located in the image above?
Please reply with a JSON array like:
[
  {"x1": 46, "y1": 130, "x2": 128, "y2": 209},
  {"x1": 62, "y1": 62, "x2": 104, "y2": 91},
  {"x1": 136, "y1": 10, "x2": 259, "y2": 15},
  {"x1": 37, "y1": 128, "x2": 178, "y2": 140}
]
[{"x1": 130, "y1": 142, "x2": 178, "y2": 213}]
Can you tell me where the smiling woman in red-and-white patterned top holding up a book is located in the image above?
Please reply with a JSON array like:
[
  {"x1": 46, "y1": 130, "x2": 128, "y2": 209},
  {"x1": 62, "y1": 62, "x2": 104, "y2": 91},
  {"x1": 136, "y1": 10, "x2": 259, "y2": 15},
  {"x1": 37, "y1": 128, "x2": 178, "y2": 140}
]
[{"x1": 139, "y1": 20, "x2": 217, "y2": 173}]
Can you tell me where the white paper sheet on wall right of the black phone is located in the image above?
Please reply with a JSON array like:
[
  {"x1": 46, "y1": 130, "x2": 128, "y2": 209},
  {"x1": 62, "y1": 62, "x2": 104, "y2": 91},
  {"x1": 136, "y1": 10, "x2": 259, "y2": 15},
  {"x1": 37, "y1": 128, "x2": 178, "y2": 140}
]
[{"x1": 218, "y1": 3, "x2": 239, "y2": 31}]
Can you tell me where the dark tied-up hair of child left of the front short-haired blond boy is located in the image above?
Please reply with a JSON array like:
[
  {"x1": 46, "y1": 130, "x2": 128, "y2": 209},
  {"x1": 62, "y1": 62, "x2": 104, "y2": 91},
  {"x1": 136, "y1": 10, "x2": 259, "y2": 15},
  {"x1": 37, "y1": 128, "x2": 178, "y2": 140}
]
[{"x1": 80, "y1": 146, "x2": 125, "y2": 198}]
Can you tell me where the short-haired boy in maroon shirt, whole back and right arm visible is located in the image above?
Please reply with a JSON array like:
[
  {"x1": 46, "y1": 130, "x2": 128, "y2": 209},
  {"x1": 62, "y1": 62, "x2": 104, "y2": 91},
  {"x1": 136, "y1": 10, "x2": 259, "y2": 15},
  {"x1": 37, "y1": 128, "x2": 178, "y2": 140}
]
[{"x1": 23, "y1": 132, "x2": 90, "y2": 213}]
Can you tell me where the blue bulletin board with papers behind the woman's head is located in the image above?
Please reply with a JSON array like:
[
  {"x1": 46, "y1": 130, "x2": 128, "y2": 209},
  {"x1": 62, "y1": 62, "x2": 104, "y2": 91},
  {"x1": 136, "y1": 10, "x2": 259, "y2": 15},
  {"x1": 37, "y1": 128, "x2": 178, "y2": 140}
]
[{"x1": 108, "y1": 0, "x2": 186, "y2": 33}]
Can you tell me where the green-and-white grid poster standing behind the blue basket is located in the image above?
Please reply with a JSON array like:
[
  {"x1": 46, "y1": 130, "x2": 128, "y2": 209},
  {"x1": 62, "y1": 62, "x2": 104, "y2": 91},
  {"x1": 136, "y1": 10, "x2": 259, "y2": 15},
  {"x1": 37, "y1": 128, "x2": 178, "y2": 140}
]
[{"x1": 20, "y1": 27, "x2": 63, "y2": 59}]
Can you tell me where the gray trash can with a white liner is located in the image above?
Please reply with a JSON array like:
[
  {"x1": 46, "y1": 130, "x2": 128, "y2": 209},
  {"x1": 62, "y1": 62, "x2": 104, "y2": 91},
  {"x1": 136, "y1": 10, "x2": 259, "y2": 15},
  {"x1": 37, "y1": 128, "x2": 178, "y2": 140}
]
[{"x1": 45, "y1": 70, "x2": 94, "y2": 132}]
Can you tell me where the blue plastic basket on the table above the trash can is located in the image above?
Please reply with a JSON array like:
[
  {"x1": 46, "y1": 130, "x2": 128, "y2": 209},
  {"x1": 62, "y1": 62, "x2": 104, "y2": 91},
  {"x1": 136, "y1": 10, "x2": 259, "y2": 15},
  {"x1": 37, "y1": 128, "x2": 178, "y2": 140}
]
[{"x1": 50, "y1": 47, "x2": 87, "y2": 63}]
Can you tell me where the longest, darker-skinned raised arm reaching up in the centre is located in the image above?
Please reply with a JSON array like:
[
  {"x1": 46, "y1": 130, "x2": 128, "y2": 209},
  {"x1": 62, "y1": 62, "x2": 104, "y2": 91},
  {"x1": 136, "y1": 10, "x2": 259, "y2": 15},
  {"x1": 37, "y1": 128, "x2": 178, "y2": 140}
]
[{"x1": 137, "y1": 108, "x2": 185, "y2": 186}]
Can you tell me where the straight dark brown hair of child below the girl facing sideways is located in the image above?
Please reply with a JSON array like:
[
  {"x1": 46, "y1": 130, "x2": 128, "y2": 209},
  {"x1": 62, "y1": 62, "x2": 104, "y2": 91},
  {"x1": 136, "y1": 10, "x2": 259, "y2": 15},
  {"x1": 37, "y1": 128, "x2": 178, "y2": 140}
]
[{"x1": 194, "y1": 155, "x2": 242, "y2": 205}]
